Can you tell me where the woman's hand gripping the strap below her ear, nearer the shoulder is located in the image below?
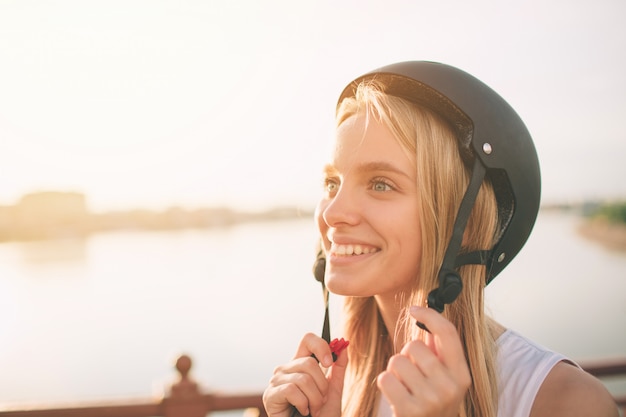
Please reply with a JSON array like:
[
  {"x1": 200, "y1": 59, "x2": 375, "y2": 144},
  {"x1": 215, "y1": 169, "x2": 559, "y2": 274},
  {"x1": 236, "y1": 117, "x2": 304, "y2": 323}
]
[{"x1": 377, "y1": 307, "x2": 472, "y2": 417}]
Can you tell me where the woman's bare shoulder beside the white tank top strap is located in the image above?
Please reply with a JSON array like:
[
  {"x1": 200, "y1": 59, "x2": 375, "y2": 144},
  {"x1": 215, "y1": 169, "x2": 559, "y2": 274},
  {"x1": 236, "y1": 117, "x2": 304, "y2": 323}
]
[{"x1": 530, "y1": 362, "x2": 619, "y2": 417}]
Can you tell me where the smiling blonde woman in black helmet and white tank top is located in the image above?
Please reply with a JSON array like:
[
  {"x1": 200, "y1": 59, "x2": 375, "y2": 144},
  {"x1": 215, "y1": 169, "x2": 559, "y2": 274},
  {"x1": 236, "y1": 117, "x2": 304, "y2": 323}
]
[{"x1": 264, "y1": 62, "x2": 617, "y2": 417}]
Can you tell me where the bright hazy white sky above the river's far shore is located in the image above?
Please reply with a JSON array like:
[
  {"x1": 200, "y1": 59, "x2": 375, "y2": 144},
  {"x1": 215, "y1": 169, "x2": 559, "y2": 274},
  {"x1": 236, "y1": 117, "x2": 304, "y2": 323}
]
[{"x1": 0, "y1": 0, "x2": 626, "y2": 211}]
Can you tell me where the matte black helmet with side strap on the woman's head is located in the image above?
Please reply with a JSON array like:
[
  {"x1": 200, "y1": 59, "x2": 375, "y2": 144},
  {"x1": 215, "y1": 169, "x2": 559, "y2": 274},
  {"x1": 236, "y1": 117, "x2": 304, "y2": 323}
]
[{"x1": 339, "y1": 61, "x2": 541, "y2": 309}]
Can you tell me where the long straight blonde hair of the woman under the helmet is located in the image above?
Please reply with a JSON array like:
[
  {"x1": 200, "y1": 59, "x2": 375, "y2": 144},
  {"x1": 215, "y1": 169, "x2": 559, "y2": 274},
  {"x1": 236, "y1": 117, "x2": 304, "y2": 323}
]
[{"x1": 337, "y1": 81, "x2": 497, "y2": 417}]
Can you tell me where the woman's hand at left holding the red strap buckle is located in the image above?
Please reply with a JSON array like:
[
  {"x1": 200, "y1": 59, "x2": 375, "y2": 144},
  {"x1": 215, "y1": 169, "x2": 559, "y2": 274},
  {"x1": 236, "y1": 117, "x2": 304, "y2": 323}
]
[{"x1": 263, "y1": 333, "x2": 348, "y2": 417}]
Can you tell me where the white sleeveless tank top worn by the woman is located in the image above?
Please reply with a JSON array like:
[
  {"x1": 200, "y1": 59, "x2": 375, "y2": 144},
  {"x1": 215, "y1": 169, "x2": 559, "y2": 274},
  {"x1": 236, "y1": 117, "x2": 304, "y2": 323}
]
[{"x1": 378, "y1": 329, "x2": 571, "y2": 417}]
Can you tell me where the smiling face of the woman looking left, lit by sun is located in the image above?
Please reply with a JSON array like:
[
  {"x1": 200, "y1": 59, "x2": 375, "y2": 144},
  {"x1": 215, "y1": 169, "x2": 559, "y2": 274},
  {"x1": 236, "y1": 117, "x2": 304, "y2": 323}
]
[{"x1": 316, "y1": 114, "x2": 421, "y2": 296}]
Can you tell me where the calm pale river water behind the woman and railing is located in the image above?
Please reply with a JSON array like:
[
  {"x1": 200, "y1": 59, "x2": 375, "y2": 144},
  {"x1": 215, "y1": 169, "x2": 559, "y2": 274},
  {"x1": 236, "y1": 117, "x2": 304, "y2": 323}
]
[{"x1": 0, "y1": 212, "x2": 626, "y2": 406}]
